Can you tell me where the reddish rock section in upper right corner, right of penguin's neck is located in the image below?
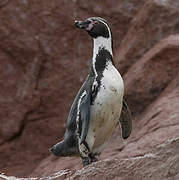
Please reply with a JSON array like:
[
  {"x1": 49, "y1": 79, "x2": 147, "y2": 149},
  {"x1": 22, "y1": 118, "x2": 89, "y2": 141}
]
[{"x1": 116, "y1": 0, "x2": 179, "y2": 74}]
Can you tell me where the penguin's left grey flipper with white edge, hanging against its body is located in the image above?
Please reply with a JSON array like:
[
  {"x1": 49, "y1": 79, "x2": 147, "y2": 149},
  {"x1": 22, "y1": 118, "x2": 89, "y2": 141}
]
[{"x1": 79, "y1": 88, "x2": 92, "y2": 144}]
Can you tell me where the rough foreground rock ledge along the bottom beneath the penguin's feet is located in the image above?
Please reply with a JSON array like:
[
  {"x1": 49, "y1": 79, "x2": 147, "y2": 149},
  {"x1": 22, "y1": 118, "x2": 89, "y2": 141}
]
[{"x1": 0, "y1": 138, "x2": 179, "y2": 180}]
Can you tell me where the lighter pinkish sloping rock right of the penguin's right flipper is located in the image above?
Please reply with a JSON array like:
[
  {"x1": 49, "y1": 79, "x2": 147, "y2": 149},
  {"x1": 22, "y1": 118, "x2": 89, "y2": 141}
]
[{"x1": 120, "y1": 74, "x2": 179, "y2": 158}]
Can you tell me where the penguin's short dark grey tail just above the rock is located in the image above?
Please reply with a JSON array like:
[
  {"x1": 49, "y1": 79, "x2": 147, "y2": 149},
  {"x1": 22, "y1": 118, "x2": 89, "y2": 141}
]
[{"x1": 50, "y1": 141, "x2": 78, "y2": 157}]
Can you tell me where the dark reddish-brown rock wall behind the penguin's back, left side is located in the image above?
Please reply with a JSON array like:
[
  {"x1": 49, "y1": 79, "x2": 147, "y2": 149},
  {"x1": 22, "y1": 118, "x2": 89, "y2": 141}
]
[{"x1": 0, "y1": 0, "x2": 144, "y2": 176}]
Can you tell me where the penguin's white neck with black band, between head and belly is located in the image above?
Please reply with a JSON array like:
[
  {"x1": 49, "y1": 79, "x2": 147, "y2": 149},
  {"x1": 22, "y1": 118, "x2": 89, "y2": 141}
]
[{"x1": 92, "y1": 36, "x2": 114, "y2": 77}]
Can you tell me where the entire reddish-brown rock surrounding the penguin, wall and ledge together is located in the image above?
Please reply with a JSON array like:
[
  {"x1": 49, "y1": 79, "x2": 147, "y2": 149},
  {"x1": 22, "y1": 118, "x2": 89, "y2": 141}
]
[{"x1": 0, "y1": 0, "x2": 179, "y2": 180}]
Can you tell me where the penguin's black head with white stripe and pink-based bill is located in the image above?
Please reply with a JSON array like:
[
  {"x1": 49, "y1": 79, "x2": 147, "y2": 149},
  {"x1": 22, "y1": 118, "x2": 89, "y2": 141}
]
[{"x1": 75, "y1": 17, "x2": 111, "y2": 38}]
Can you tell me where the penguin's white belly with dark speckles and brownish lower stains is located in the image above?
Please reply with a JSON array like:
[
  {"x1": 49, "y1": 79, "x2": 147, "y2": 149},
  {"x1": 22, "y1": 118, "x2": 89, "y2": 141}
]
[{"x1": 86, "y1": 64, "x2": 124, "y2": 154}]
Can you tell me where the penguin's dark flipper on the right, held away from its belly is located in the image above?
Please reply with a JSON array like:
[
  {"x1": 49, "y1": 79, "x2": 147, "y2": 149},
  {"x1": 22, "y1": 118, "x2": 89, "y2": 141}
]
[{"x1": 119, "y1": 99, "x2": 132, "y2": 139}]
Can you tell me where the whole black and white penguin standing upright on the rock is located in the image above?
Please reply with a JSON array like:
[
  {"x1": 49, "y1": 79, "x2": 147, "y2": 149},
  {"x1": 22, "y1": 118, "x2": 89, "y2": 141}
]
[{"x1": 51, "y1": 17, "x2": 132, "y2": 166}]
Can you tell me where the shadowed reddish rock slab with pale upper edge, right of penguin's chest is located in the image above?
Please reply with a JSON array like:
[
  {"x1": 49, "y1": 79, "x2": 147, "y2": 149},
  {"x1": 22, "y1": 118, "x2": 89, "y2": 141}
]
[{"x1": 124, "y1": 35, "x2": 179, "y2": 114}]
